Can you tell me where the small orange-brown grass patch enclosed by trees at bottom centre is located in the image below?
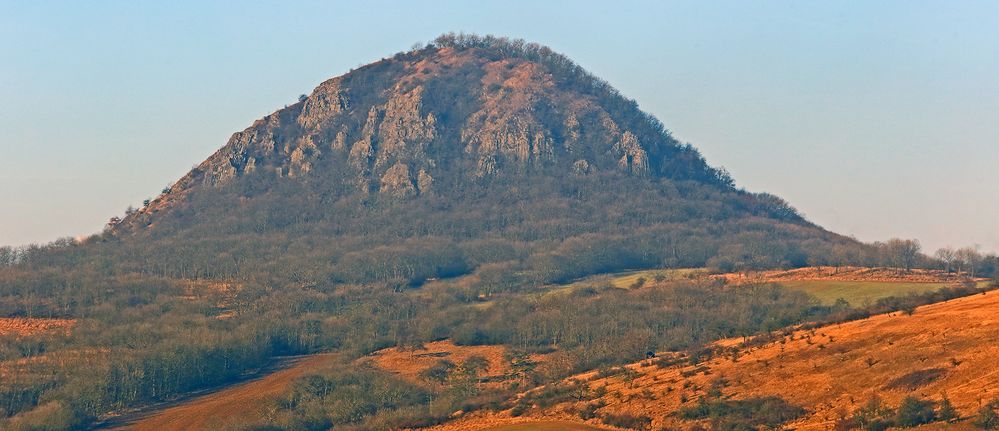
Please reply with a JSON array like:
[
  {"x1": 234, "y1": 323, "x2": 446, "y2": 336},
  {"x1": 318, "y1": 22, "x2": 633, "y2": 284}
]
[{"x1": 372, "y1": 340, "x2": 510, "y2": 384}]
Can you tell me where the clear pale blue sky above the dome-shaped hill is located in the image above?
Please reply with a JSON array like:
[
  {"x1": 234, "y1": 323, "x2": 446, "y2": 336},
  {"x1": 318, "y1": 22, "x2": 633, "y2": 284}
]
[{"x1": 0, "y1": 0, "x2": 999, "y2": 255}]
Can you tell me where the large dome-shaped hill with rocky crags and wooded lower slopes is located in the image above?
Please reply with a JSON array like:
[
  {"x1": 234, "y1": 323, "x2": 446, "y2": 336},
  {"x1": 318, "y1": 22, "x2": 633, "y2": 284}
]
[{"x1": 108, "y1": 34, "x2": 858, "y2": 290}]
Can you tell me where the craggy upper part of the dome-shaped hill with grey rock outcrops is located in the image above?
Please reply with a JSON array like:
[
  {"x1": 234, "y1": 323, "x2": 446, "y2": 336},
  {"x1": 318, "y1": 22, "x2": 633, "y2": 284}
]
[{"x1": 129, "y1": 38, "x2": 730, "y2": 224}]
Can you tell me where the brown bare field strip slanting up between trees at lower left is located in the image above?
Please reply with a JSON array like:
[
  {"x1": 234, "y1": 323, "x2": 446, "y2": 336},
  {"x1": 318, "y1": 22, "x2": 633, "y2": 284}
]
[{"x1": 104, "y1": 354, "x2": 338, "y2": 431}]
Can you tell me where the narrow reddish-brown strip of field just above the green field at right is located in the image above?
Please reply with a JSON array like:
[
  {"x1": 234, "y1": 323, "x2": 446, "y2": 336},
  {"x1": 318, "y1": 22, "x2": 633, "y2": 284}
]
[{"x1": 711, "y1": 266, "x2": 982, "y2": 284}]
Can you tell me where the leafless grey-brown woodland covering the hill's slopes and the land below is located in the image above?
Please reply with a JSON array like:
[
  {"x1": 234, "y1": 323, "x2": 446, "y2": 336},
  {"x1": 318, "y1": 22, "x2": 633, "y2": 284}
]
[{"x1": 0, "y1": 36, "x2": 999, "y2": 430}]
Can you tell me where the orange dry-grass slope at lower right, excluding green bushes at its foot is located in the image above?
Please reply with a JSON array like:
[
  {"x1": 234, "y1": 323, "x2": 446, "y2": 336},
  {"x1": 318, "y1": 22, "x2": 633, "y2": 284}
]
[{"x1": 426, "y1": 292, "x2": 999, "y2": 431}]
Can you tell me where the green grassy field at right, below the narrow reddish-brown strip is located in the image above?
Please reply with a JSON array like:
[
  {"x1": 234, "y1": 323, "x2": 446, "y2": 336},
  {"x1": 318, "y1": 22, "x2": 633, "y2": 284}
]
[{"x1": 778, "y1": 280, "x2": 948, "y2": 307}]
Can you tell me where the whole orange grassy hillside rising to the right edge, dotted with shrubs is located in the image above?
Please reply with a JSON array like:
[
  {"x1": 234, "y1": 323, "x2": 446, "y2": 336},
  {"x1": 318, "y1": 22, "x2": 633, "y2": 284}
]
[{"x1": 433, "y1": 286, "x2": 999, "y2": 430}]
